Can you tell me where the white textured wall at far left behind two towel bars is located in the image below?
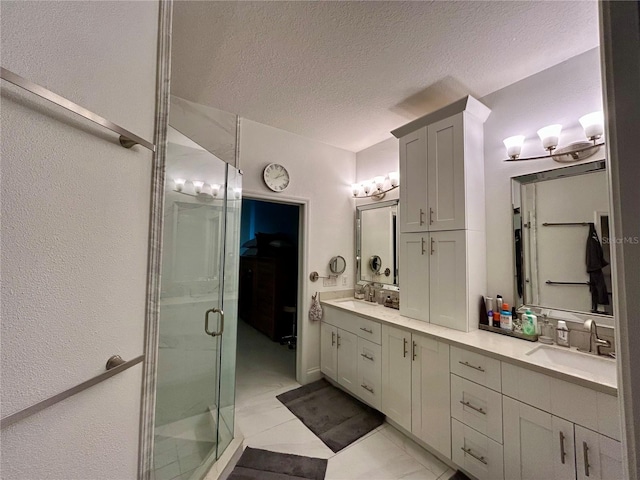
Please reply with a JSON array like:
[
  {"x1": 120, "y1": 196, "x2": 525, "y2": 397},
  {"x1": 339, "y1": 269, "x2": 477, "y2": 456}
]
[{"x1": 0, "y1": 1, "x2": 158, "y2": 479}]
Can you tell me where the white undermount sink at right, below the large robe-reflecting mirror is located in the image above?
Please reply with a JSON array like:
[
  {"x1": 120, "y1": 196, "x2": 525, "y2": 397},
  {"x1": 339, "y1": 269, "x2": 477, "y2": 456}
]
[{"x1": 527, "y1": 345, "x2": 616, "y2": 382}]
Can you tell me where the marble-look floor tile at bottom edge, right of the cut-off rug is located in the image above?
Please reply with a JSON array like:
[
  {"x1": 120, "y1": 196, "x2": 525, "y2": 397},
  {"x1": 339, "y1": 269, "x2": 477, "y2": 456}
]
[{"x1": 325, "y1": 431, "x2": 438, "y2": 480}]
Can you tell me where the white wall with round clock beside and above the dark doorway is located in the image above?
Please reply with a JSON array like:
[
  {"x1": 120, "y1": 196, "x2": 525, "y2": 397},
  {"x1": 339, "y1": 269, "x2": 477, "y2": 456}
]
[{"x1": 240, "y1": 119, "x2": 356, "y2": 382}]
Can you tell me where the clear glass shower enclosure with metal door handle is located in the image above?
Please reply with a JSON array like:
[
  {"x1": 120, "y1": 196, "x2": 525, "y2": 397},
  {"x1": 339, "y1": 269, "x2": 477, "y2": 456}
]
[{"x1": 154, "y1": 128, "x2": 241, "y2": 480}]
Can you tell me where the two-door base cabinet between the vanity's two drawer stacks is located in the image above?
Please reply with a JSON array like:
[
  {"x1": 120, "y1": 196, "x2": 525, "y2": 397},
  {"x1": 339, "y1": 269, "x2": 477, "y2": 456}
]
[{"x1": 382, "y1": 325, "x2": 451, "y2": 458}]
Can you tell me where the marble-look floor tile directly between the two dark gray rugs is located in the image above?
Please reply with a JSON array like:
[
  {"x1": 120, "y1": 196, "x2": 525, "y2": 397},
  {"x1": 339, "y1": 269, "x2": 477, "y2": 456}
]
[{"x1": 244, "y1": 418, "x2": 334, "y2": 458}]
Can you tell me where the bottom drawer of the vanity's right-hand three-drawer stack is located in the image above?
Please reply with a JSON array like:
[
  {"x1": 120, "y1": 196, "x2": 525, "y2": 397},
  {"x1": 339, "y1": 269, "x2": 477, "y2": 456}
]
[{"x1": 451, "y1": 418, "x2": 504, "y2": 480}]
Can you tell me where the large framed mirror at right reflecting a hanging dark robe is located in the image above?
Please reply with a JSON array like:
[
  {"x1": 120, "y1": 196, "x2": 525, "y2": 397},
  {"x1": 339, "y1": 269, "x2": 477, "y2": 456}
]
[{"x1": 512, "y1": 160, "x2": 613, "y2": 316}]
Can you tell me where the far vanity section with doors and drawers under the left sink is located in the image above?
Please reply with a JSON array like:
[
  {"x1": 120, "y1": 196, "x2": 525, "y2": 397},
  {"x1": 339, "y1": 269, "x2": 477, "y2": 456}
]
[{"x1": 320, "y1": 307, "x2": 382, "y2": 409}]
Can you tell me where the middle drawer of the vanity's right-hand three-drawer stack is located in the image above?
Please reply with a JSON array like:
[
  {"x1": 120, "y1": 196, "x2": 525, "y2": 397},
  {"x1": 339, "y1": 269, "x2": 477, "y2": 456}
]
[{"x1": 451, "y1": 374, "x2": 502, "y2": 443}]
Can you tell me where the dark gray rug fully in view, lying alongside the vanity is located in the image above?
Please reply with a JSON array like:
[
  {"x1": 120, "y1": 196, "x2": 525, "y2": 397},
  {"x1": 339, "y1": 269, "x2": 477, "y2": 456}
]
[{"x1": 276, "y1": 379, "x2": 384, "y2": 453}]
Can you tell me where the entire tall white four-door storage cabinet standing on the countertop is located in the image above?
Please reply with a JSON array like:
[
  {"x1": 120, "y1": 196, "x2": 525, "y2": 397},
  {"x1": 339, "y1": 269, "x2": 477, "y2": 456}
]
[{"x1": 392, "y1": 96, "x2": 490, "y2": 331}]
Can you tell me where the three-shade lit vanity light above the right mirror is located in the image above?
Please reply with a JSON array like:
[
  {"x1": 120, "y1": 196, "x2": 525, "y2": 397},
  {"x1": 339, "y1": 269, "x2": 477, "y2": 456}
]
[{"x1": 503, "y1": 112, "x2": 604, "y2": 163}]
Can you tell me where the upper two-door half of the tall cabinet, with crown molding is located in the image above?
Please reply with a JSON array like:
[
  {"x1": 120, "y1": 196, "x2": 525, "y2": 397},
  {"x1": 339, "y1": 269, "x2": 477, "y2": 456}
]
[{"x1": 392, "y1": 96, "x2": 490, "y2": 233}]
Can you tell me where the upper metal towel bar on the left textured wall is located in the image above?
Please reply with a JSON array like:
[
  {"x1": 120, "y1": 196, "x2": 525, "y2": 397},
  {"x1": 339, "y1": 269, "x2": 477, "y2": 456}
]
[{"x1": 0, "y1": 67, "x2": 156, "y2": 152}]
